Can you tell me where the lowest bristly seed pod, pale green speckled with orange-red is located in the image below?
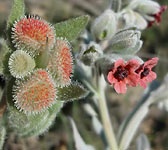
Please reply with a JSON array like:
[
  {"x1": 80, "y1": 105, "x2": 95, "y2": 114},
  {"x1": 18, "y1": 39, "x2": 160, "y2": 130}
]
[{"x1": 13, "y1": 70, "x2": 56, "y2": 114}]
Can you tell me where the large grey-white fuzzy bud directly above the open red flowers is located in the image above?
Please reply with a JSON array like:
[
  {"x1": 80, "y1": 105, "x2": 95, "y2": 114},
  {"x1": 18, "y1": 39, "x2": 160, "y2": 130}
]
[{"x1": 107, "y1": 29, "x2": 142, "y2": 54}]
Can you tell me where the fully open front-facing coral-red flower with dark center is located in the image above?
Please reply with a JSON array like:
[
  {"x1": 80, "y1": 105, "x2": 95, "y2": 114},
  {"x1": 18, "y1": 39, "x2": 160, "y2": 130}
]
[{"x1": 107, "y1": 59, "x2": 139, "y2": 93}]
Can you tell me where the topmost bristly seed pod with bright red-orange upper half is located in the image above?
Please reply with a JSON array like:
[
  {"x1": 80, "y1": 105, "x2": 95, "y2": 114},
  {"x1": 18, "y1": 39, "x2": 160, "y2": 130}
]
[{"x1": 12, "y1": 16, "x2": 55, "y2": 56}]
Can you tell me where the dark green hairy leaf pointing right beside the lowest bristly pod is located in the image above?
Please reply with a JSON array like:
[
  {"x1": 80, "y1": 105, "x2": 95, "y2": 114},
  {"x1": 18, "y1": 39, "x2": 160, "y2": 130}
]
[{"x1": 56, "y1": 82, "x2": 88, "y2": 102}]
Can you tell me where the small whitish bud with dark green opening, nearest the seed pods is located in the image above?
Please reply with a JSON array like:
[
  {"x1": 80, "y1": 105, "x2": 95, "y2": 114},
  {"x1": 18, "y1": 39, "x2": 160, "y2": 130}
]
[{"x1": 79, "y1": 42, "x2": 103, "y2": 66}]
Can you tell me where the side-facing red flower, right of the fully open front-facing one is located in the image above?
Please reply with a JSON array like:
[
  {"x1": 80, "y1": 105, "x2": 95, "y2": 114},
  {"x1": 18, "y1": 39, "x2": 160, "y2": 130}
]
[{"x1": 135, "y1": 57, "x2": 158, "y2": 88}]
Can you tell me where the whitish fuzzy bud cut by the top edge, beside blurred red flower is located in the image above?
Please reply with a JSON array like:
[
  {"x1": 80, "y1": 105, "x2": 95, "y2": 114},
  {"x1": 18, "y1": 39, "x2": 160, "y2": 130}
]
[{"x1": 135, "y1": 0, "x2": 160, "y2": 15}]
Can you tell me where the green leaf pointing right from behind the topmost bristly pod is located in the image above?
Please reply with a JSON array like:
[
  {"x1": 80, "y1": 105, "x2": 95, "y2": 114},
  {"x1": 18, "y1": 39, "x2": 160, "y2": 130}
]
[{"x1": 54, "y1": 15, "x2": 89, "y2": 41}]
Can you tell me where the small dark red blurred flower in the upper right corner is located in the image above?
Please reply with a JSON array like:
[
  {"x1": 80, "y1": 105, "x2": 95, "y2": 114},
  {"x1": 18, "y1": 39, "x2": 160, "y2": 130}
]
[{"x1": 148, "y1": 6, "x2": 167, "y2": 27}]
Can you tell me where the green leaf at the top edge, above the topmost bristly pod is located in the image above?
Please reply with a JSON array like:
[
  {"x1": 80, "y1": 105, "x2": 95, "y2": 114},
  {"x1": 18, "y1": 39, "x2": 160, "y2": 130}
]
[{"x1": 7, "y1": 0, "x2": 25, "y2": 27}]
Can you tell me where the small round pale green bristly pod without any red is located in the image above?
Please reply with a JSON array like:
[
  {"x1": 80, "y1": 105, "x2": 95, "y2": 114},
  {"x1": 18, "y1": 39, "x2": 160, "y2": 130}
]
[{"x1": 8, "y1": 50, "x2": 35, "y2": 78}]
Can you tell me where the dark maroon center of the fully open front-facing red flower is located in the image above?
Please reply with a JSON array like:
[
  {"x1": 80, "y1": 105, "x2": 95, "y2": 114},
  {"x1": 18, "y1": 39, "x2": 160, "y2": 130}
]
[{"x1": 114, "y1": 66, "x2": 128, "y2": 81}]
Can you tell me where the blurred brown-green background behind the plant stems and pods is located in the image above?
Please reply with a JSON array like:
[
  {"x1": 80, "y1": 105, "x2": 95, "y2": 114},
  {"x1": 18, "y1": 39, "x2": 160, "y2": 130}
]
[{"x1": 0, "y1": 0, "x2": 168, "y2": 150}]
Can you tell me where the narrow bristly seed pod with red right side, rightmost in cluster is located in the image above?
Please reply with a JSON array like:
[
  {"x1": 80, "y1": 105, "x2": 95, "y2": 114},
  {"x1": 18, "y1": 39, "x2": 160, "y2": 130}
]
[{"x1": 47, "y1": 38, "x2": 73, "y2": 86}]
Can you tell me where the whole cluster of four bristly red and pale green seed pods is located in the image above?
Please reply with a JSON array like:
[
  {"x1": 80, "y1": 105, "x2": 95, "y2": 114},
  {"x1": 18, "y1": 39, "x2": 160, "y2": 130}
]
[{"x1": 8, "y1": 16, "x2": 73, "y2": 114}]
